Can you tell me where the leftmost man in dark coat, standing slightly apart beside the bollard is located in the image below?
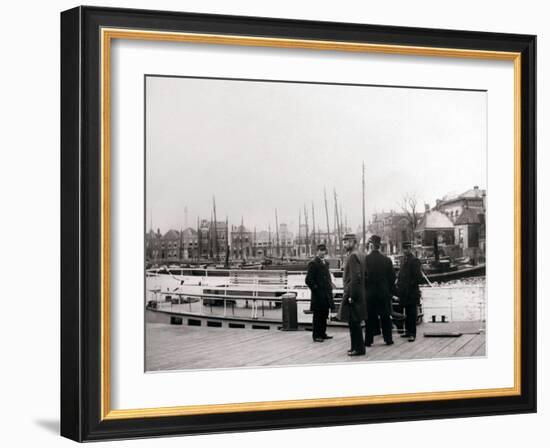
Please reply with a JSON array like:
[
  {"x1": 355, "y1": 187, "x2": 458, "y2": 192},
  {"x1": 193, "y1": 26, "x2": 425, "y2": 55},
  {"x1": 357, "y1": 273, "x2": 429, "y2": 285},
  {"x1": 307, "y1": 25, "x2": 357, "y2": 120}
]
[{"x1": 306, "y1": 244, "x2": 334, "y2": 342}]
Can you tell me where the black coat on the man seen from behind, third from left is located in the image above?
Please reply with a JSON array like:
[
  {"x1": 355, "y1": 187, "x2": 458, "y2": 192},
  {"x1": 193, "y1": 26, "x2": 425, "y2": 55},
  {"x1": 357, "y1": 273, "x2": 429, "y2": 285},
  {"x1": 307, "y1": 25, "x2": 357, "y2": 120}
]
[{"x1": 365, "y1": 249, "x2": 395, "y2": 314}]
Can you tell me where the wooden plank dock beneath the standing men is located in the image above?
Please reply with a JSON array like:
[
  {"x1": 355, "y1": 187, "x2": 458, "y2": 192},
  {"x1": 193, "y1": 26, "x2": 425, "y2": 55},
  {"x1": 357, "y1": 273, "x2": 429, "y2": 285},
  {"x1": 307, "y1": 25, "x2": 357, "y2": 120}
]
[{"x1": 145, "y1": 322, "x2": 486, "y2": 371}]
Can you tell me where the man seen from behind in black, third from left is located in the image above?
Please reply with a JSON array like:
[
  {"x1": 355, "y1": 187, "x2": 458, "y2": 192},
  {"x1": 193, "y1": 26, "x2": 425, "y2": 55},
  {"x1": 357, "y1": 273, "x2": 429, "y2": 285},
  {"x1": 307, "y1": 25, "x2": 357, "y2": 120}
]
[{"x1": 365, "y1": 235, "x2": 395, "y2": 347}]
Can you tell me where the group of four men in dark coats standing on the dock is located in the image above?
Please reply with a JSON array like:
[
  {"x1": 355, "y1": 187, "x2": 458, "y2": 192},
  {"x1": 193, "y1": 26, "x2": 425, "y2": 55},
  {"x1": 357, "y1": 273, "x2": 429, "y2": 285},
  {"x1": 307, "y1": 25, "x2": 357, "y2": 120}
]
[{"x1": 306, "y1": 233, "x2": 422, "y2": 356}]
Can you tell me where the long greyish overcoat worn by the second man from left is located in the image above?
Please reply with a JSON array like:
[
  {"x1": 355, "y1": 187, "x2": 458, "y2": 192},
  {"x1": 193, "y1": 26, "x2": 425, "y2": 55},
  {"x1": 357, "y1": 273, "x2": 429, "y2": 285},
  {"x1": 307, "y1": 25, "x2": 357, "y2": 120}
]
[{"x1": 338, "y1": 250, "x2": 367, "y2": 322}]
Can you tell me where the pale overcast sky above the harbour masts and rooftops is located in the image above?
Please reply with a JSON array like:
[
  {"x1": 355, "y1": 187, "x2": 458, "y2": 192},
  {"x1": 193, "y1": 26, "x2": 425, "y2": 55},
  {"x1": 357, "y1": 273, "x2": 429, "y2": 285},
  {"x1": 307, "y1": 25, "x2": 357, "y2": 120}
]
[{"x1": 146, "y1": 77, "x2": 487, "y2": 232}]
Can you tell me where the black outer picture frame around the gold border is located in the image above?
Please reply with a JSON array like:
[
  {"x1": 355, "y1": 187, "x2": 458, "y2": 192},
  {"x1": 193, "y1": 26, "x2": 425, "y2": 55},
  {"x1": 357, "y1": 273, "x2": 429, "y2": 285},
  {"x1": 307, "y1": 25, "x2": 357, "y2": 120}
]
[{"x1": 61, "y1": 7, "x2": 537, "y2": 441}]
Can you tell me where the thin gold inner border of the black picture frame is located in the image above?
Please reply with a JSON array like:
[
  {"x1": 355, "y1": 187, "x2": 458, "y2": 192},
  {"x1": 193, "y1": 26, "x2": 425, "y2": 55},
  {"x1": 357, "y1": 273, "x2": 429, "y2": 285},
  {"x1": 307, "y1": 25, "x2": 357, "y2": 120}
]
[{"x1": 100, "y1": 28, "x2": 521, "y2": 420}]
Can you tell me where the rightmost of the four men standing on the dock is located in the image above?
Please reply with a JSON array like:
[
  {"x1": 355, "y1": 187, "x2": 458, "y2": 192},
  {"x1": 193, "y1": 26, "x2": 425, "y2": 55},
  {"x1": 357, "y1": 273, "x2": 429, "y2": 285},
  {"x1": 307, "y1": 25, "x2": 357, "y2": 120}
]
[{"x1": 397, "y1": 243, "x2": 423, "y2": 342}]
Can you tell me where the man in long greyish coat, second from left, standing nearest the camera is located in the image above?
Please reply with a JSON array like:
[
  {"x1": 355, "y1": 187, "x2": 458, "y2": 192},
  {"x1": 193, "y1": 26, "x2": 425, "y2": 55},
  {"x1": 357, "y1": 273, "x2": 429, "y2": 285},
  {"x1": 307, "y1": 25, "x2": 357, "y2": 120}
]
[{"x1": 338, "y1": 233, "x2": 367, "y2": 356}]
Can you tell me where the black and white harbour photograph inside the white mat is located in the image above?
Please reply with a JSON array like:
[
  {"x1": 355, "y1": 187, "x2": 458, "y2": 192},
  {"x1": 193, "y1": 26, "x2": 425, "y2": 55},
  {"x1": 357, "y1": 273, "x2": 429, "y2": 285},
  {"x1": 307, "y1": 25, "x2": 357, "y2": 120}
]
[{"x1": 143, "y1": 74, "x2": 493, "y2": 372}]
